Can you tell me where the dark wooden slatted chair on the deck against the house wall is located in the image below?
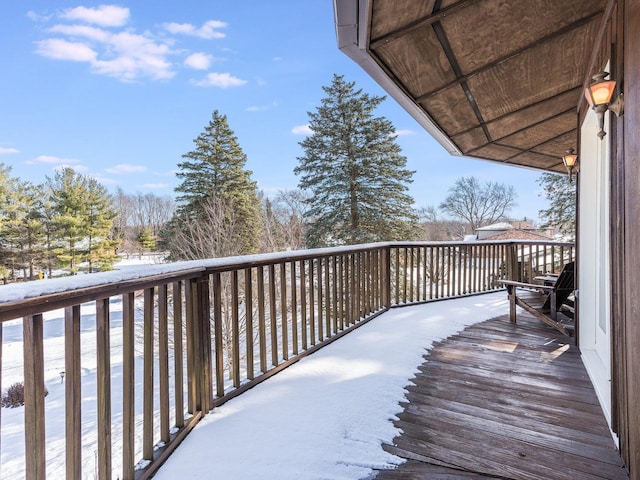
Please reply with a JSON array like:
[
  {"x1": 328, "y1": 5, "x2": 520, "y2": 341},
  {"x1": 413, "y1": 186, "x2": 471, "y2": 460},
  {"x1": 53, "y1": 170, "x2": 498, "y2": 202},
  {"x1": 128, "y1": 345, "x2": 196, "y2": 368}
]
[{"x1": 498, "y1": 262, "x2": 575, "y2": 336}]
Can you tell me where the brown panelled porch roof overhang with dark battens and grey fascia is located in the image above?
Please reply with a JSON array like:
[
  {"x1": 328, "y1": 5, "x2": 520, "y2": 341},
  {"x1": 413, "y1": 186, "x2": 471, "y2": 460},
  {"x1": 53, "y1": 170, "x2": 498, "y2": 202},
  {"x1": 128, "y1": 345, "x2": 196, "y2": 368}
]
[{"x1": 334, "y1": 0, "x2": 607, "y2": 172}]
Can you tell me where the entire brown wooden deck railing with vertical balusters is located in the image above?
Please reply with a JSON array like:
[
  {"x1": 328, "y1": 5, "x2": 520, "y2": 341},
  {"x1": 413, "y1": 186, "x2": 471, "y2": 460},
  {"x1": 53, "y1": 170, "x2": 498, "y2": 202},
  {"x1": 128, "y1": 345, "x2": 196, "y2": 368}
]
[{"x1": 0, "y1": 242, "x2": 573, "y2": 479}]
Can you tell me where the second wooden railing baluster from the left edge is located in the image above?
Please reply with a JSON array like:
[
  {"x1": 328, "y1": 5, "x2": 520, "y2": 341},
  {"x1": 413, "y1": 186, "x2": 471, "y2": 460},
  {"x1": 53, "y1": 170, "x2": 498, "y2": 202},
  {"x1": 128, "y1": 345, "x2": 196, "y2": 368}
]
[{"x1": 64, "y1": 305, "x2": 81, "y2": 478}]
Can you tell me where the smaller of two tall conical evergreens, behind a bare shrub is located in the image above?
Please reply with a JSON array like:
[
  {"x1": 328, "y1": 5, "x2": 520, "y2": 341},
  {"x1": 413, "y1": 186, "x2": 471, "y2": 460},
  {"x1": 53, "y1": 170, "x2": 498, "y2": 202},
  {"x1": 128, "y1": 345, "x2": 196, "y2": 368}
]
[{"x1": 170, "y1": 110, "x2": 261, "y2": 258}]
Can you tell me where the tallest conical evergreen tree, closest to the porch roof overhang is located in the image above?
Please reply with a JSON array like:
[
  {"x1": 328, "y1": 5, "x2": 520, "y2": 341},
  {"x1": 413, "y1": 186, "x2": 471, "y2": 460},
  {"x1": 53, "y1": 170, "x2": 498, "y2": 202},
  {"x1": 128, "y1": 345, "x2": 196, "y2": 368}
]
[{"x1": 294, "y1": 75, "x2": 418, "y2": 247}]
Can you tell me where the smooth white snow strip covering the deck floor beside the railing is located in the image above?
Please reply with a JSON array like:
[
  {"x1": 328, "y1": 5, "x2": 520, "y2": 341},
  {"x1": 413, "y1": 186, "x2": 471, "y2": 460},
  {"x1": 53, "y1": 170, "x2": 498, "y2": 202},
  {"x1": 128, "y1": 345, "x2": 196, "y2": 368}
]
[{"x1": 154, "y1": 292, "x2": 508, "y2": 480}]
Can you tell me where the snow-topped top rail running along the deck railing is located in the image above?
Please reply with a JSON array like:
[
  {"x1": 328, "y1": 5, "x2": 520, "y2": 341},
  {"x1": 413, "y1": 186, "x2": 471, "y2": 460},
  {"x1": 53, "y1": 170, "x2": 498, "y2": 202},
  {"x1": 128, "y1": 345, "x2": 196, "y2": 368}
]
[{"x1": 0, "y1": 240, "x2": 573, "y2": 322}]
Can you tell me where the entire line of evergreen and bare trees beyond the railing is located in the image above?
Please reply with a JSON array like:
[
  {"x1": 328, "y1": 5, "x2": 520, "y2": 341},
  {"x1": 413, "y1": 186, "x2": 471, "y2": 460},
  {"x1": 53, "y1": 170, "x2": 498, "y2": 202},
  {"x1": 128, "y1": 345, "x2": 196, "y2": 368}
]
[{"x1": 0, "y1": 75, "x2": 575, "y2": 281}]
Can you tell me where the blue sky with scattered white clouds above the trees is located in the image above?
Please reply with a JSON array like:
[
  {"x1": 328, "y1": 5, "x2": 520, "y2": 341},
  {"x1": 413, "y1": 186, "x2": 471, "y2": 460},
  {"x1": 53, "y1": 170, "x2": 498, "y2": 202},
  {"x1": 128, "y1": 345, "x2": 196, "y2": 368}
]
[{"x1": 0, "y1": 0, "x2": 545, "y2": 218}]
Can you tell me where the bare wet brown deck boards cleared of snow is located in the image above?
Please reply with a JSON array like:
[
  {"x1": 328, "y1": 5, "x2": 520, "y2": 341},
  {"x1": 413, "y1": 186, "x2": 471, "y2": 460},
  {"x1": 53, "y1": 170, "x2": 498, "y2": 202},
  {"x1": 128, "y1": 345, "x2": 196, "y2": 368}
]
[{"x1": 375, "y1": 312, "x2": 629, "y2": 480}]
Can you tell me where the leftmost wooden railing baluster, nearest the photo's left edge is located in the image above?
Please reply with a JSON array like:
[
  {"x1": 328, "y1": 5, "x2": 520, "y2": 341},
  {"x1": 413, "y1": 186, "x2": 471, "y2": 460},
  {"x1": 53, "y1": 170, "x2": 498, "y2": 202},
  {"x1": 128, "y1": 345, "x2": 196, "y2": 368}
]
[{"x1": 22, "y1": 314, "x2": 46, "y2": 480}]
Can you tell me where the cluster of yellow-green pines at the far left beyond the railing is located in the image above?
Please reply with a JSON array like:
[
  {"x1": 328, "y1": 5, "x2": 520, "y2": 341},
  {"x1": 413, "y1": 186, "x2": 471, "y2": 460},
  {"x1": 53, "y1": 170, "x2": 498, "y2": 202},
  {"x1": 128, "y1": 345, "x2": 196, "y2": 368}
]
[{"x1": 0, "y1": 164, "x2": 118, "y2": 282}]
